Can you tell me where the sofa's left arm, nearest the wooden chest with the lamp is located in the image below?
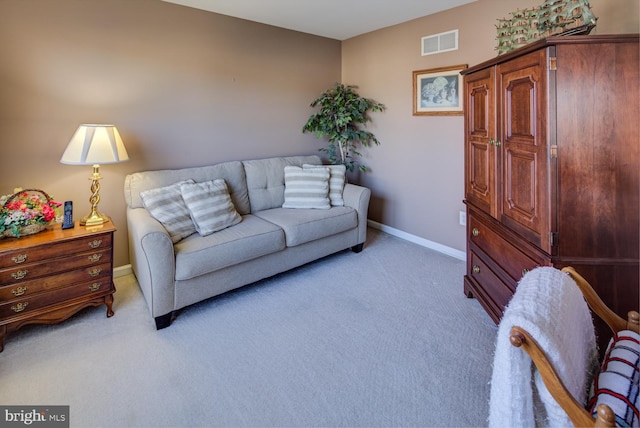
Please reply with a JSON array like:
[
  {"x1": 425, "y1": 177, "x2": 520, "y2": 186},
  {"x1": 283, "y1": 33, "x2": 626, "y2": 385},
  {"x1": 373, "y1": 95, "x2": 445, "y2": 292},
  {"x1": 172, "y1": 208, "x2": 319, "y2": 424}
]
[{"x1": 127, "y1": 208, "x2": 176, "y2": 318}]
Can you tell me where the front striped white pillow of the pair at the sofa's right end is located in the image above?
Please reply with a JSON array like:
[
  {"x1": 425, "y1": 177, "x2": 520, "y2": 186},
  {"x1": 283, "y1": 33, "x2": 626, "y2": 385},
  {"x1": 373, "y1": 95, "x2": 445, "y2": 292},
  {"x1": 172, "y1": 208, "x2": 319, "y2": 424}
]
[{"x1": 282, "y1": 165, "x2": 331, "y2": 210}]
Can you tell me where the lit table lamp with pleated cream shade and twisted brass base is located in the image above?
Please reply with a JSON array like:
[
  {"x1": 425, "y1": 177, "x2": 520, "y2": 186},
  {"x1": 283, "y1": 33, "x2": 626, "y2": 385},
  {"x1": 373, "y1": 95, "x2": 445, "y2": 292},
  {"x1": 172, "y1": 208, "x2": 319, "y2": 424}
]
[{"x1": 60, "y1": 124, "x2": 129, "y2": 226}]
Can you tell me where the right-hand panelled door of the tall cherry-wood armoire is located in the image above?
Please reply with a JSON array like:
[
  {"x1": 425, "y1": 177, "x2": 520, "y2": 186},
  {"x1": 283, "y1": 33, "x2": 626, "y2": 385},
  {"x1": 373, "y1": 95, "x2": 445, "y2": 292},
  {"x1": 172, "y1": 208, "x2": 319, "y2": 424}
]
[{"x1": 496, "y1": 49, "x2": 551, "y2": 253}]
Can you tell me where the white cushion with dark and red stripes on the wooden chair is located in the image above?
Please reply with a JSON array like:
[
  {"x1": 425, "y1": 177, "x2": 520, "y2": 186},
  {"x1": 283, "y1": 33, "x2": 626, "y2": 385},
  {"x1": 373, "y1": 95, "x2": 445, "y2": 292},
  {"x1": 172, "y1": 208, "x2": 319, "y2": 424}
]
[{"x1": 589, "y1": 330, "x2": 640, "y2": 427}]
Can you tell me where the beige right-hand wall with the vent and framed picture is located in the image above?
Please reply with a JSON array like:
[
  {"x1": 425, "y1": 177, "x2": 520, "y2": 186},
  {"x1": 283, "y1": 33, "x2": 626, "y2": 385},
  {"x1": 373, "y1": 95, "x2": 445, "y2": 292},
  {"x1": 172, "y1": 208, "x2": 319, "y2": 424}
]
[{"x1": 342, "y1": 0, "x2": 640, "y2": 251}]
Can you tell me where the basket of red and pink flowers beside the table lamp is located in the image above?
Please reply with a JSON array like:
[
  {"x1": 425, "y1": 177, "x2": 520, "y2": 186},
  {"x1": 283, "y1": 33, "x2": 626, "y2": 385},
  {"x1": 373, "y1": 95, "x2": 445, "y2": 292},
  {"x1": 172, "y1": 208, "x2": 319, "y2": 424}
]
[{"x1": 0, "y1": 188, "x2": 62, "y2": 238}]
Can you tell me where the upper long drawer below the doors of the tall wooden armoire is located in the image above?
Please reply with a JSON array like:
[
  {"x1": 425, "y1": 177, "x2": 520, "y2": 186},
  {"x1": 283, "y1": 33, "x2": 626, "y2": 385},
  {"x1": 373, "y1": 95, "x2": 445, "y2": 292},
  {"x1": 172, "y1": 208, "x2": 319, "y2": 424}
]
[{"x1": 469, "y1": 214, "x2": 545, "y2": 283}]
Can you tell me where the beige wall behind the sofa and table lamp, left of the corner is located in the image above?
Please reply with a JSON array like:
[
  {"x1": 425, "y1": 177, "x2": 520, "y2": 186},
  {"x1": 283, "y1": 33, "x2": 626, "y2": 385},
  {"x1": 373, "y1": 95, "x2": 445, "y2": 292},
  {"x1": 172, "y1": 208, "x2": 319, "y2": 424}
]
[{"x1": 0, "y1": 0, "x2": 340, "y2": 266}]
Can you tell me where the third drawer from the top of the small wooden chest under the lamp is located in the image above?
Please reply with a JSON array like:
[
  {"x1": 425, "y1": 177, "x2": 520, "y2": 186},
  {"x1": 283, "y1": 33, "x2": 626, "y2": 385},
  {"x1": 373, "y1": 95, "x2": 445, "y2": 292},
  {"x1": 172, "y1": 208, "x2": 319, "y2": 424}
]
[{"x1": 0, "y1": 262, "x2": 111, "y2": 302}]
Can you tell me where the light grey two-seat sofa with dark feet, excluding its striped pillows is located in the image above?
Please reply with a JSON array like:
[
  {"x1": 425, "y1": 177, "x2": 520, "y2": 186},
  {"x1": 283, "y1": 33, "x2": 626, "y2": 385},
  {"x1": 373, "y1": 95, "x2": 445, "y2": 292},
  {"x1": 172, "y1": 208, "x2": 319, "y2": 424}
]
[{"x1": 124, "y1": 156, "x2": 371, "y2": 329}]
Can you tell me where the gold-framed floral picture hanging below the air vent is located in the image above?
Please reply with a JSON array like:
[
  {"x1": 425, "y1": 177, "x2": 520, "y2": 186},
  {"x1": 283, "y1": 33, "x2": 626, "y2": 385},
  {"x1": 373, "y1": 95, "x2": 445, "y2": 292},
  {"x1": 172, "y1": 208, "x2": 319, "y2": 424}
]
[{"x1": 413, "y1": 64, "x2": 467, "y2": 116}]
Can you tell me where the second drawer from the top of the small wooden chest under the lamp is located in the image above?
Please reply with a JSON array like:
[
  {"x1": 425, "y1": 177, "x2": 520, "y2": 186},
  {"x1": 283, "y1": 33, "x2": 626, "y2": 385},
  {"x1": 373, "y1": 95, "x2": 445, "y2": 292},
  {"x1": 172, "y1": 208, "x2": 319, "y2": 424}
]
[{"x1": 0, "y1": 249, "x2": 111, "y2": 285}]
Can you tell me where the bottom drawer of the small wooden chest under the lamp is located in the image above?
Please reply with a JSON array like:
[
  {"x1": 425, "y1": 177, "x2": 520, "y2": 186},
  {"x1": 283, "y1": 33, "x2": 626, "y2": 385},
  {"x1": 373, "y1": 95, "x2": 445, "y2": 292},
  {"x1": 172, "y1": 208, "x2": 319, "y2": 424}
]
[{"x1": 0, "y1": 277, "x2": 113, "y2": 320}]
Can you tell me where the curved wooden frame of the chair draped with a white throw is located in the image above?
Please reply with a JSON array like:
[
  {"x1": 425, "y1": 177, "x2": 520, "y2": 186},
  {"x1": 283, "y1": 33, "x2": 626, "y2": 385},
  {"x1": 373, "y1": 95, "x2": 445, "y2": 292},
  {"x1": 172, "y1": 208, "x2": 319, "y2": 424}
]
[{"x1": 509, "y1": 266, "x2": 640, "y2": 427}]
